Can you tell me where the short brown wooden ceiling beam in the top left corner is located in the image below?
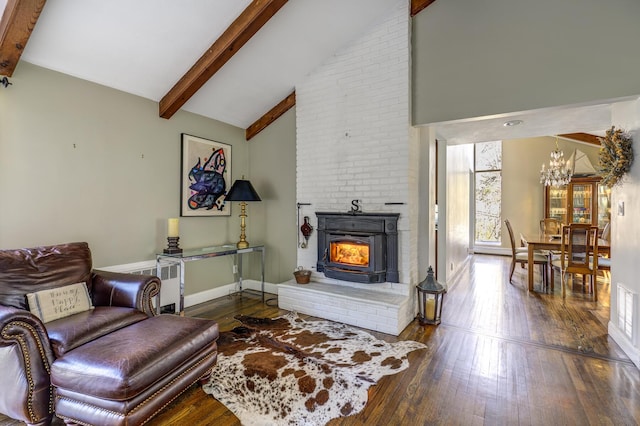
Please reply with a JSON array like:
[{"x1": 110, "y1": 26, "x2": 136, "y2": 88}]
[{"x1": 0, "y1": 0, "x2": 46, "y2": 77}]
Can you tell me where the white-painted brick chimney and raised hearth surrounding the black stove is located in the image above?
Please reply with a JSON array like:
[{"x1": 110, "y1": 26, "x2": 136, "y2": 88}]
[{"x1": 278, "y1": 0, "x2": 418, "y2": 335}]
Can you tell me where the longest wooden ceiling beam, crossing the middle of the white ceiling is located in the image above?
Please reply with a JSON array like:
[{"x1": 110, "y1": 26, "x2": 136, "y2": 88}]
[{"x1": 160, "y1": 0, "x2": 287, "y2": 119}]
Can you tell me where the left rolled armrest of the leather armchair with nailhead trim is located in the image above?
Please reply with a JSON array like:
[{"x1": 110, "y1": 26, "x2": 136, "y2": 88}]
[{"x1": 0, "y1": 305, "x2": 54, "y2": 424}]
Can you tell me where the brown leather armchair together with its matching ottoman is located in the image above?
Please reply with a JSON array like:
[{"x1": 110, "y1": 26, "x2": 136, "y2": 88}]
[{"x1": 0, "y1": 243, "x2": 218, "y2": 425}]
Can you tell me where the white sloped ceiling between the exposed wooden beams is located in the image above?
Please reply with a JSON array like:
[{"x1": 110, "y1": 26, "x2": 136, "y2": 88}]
[{"x1": 20, "y1": 0, "x2": 399, "y2": 128}]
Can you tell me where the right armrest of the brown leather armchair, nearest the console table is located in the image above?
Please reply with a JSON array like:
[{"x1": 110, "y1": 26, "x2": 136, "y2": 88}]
[{"x1": 91, "y1": 270, "x2": 161, "y2": 316}]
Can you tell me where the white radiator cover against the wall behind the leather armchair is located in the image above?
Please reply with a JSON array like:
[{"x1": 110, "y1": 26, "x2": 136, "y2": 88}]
[{"x1": 96, "y1": 260, "x2": 180, "y2": 313}]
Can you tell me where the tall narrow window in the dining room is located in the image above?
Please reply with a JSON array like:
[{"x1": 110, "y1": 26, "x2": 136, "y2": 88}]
[{"x1": 474, "y1": 141, "x2": 502, "y2": 244}]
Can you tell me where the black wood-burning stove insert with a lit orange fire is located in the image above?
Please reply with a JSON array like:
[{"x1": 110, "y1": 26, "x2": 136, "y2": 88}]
[{"x1": 316, "y1": 212, "x2": 400, "y2": 283}]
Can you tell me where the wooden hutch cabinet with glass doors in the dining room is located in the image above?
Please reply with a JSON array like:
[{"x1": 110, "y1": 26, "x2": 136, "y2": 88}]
[{"x1": 544, "y1": 176, "x2": 611, "y2": 229}]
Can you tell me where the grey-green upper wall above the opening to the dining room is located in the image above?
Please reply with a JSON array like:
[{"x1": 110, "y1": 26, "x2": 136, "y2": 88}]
[{"x1": 412, "y1": 0, "x2": 640, "y2": 125}]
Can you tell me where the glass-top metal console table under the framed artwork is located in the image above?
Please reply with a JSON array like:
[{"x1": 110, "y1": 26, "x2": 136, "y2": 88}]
[{"x1": 156, "y1": 244, "x2": 264, "y2": 315}]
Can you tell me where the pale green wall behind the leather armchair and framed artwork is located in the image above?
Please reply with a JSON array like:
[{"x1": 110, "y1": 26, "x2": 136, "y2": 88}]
[{"x1": 0, "y1": 62, "x2": 248, "y2": 294}]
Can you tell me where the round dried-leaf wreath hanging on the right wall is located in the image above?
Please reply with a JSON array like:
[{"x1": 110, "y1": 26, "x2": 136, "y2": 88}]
[{"x1": 598, "y1": 126, "x2": 633, "y2": 188}]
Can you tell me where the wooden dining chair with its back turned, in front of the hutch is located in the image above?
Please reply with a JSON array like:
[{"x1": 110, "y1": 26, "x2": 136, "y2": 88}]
[{"x1": 551, "y1": 223, "x2": 598, "y2": 302}]
